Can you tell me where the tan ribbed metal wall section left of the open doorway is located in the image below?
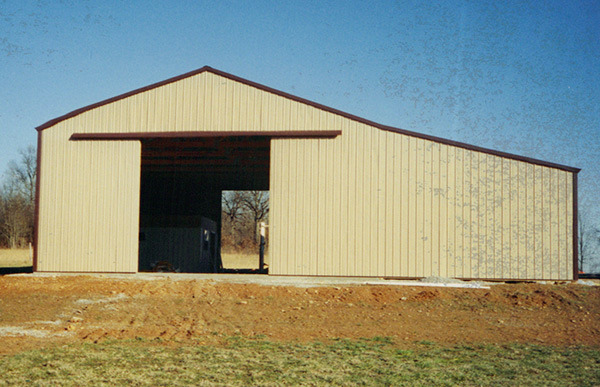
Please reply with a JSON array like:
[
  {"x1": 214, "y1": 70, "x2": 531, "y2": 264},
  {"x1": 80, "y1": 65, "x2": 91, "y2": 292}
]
[{"x1": 37, "y1": 130, "x2": 140, "y2": 272}]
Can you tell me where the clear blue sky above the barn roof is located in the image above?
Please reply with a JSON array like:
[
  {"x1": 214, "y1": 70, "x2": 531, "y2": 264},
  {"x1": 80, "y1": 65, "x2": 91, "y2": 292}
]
[{"x1": 0, "y1": 0, "x2": 600, "y2": 224}]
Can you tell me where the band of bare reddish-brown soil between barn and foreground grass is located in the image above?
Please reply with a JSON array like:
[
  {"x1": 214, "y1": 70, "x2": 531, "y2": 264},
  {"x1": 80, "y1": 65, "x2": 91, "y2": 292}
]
[{"x1": 0, "y1": 276, "x2": 600, "y2": 354}]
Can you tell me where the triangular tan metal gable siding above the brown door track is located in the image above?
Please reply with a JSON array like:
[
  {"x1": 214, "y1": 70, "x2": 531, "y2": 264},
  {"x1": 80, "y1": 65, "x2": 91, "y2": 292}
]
[{"x1": 65, "y1": 72, "x2": 341, "y2": 133}]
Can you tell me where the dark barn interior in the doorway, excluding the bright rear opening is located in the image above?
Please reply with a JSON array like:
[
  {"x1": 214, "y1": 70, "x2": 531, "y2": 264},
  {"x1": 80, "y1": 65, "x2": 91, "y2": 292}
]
[{"x1": 138, "y1": 136, "x2": 270, "y2": 273}]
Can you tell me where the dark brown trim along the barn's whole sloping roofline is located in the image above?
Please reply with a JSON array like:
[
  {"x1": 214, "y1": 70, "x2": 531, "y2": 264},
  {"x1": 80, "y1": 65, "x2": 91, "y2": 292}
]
[{"x1": 36, "y1": 66, "x2": 580, "y2": 173}]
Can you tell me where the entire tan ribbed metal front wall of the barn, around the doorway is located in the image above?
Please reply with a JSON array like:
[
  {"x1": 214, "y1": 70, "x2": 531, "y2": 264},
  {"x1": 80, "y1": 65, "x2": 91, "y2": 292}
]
[{"x1": 37, "y1": 72, "x2": 574, "y2": 280}]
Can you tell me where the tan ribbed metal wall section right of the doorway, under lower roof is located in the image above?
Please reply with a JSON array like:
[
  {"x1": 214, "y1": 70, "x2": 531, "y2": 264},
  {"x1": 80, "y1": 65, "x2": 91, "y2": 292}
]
[{"x1": 270, "y1": 121, "x2": 573, "y2": 280}]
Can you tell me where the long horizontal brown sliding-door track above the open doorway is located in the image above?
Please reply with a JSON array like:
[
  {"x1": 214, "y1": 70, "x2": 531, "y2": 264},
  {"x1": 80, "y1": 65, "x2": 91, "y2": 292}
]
[{"x1": 70, "y1": 130, "x2": 342, "y2": 140}]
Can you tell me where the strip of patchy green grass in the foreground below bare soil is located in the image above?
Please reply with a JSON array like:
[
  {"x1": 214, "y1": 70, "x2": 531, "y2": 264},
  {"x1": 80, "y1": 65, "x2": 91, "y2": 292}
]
[{"x1": 0, "y1": 337, "x2": 600, "y2": 386}]
